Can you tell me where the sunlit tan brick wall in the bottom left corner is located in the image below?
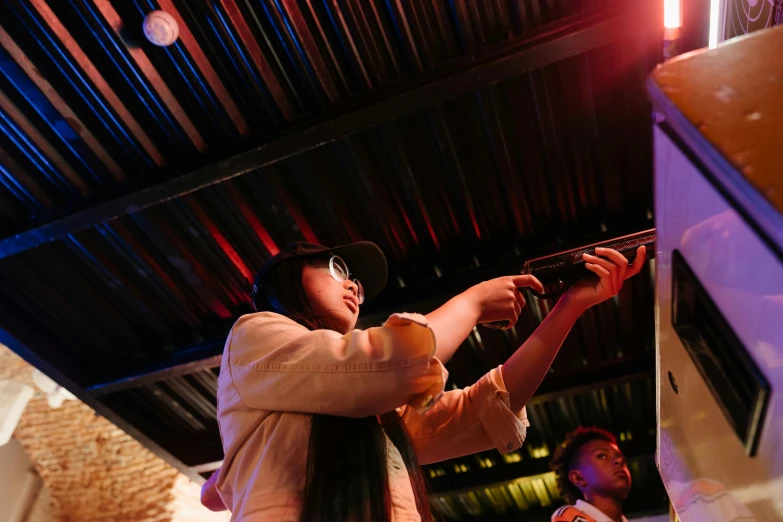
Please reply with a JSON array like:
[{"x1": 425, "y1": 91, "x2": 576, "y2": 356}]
[{"x1": 0, "y1": 345, "x2": 229, "y2": 522}]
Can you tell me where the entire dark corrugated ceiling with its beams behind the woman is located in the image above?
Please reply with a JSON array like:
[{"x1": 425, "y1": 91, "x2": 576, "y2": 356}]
[{"x1": 0, "y1": 0, "x2": 709, "y2": 520}]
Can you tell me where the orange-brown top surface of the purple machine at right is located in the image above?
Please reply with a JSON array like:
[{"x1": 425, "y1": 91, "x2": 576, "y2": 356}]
[{"x1": 650, "y1": 27, "x2": 783, "y2": 214}]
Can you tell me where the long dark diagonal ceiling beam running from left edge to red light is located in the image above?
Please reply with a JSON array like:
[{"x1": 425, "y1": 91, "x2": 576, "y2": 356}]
[{"x1": 0, "y1": 2, "x2": 661, "y2": 259}]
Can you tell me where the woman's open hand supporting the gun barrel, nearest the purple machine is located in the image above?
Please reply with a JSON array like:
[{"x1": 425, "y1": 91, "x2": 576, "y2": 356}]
[{"x1": 566, "y1": 246, "x2": 647, "y2": 310}]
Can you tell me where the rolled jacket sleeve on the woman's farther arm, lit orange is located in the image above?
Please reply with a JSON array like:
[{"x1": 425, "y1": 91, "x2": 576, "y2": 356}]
[{"x1": 403, "y1": 367, "x2": 530, "y2": 464}]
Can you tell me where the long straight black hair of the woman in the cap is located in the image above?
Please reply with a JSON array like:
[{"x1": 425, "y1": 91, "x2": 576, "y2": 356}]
[{"x1": 254, "y1": 258, "x2": 433, "y2": 522}]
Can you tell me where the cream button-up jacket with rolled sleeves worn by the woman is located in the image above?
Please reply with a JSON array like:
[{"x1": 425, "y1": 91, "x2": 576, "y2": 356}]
[{"x1": 216, "y1": 312, "x2": 529, "y2": 522}]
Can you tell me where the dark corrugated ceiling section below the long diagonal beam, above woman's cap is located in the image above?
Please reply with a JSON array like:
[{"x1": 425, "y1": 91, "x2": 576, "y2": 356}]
[{"x1": 0, "y1": 32, "x2": 653, "y2": 378}]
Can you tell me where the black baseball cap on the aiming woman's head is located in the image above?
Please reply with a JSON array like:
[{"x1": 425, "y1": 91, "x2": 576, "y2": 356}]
[{"x1": 253, "y1": 241, "x2": 389, "y2": 299}]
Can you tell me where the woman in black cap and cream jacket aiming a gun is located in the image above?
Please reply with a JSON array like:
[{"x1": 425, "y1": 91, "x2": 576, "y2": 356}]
[{"x1": 202, "y1": 242, "x2": 646, "y2": 522}]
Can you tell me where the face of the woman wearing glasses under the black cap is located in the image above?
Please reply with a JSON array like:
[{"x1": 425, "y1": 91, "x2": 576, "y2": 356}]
[{"x1": 302, "y1": 261, "x2": 359, "y2": 333}]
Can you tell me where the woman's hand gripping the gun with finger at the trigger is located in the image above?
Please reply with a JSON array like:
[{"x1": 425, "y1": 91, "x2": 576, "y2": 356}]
[{"x1": 464, "y1": 275, "x2": 544, "y2": 327}]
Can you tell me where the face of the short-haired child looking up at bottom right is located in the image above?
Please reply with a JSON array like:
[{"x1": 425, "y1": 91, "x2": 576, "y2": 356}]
[{"x1": 572, "y1": 440, "x2": 631, "y2": 500}]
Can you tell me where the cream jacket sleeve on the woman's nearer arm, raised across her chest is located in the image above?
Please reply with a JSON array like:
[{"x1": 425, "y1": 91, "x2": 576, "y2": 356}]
[{"x1": 223, "y1": 313, "x2": 447, "y2": 417}]
